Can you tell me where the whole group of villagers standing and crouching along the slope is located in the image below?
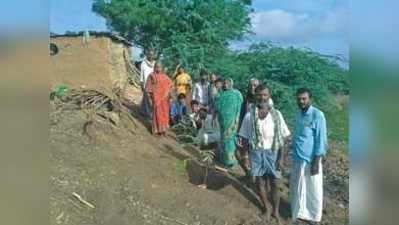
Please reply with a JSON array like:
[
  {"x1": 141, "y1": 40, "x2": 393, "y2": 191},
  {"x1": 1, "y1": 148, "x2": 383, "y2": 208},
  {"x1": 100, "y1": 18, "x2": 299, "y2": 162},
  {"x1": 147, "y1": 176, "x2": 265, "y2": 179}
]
[{"x1": 141, "y1": 49, "x2": 327, "y2": 224}]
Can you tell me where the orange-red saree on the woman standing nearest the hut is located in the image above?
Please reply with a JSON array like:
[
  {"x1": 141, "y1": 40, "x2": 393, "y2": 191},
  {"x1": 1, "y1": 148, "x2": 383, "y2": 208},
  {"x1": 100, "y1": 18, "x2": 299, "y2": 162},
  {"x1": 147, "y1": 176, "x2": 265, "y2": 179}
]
[{"x1": 145, "y1": 72, "x2": 172, "y2": 134}]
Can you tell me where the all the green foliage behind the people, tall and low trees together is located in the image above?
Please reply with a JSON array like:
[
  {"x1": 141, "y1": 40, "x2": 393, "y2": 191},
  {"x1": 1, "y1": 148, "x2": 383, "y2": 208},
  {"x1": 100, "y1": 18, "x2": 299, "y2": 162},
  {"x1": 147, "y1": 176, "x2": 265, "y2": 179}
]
[{"x1": 93, "y1": 0, "x2": 349, "y2": 141}]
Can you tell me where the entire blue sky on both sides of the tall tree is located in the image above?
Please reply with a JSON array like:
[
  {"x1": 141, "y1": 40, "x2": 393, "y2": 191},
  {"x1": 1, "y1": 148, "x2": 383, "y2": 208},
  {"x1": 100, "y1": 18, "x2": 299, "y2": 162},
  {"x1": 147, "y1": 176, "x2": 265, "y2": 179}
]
[{"x1": 50, "y1": 0, "x2": 349, "y2": 64}]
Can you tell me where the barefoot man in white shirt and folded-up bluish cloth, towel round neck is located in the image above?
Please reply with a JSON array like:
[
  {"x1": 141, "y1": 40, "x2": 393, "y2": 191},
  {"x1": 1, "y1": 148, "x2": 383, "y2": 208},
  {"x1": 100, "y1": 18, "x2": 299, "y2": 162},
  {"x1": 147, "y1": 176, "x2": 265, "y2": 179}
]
[{"x1": 238, "y1": 85, "x2": 290, "y2": 224}]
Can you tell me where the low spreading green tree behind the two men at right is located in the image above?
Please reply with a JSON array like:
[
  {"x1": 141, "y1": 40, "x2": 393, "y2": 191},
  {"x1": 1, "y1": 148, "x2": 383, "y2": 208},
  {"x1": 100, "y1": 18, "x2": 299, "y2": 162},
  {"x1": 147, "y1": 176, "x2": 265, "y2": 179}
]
[{"x1": 233, "y1": 43, "x2": 349, "y2": 124}]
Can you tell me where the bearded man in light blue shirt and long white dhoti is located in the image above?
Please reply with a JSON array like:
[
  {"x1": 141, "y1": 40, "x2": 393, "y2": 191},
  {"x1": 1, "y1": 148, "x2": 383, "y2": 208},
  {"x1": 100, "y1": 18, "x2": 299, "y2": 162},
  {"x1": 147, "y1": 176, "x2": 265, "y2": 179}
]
[{"x1": 290, "y1": 88, "x2": 327, "y2": 224}]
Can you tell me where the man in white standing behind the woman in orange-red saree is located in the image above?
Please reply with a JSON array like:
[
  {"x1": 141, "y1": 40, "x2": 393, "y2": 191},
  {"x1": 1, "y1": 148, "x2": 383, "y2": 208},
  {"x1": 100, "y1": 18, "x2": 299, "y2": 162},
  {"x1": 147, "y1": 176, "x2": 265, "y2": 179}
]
[{"x1": 140, "y1": 49, "x2": 156, "y2": 118}]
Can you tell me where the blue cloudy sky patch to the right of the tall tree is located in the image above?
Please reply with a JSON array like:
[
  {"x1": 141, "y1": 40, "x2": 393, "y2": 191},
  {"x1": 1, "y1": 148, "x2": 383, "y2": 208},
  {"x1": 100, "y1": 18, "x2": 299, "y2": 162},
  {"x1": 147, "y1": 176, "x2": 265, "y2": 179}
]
[{"x1": 242, "y1": 0, "x2": 349, "y2": 58}]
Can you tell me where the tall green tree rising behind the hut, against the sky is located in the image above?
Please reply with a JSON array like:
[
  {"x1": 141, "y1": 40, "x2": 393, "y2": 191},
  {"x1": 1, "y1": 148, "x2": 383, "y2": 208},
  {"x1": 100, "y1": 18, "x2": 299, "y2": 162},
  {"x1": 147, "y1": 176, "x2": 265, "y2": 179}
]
[{"x1": 93, "y1": 0, "x2": 252, "y2": 75}]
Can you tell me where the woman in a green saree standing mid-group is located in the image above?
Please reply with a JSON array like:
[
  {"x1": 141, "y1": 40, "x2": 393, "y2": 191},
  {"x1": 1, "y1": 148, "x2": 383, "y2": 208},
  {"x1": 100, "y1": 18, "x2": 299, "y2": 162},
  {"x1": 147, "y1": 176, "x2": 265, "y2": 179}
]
[{"x1": 214, "y1": 78, "x2": 243, "y2": 168}]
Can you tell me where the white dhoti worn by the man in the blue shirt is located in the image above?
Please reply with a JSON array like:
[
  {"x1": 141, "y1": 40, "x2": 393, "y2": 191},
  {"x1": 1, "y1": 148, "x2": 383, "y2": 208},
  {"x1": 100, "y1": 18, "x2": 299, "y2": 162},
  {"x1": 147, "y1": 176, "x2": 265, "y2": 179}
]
[{"x1": 290, "y1": 160, "x2": 323, "y2": 222}]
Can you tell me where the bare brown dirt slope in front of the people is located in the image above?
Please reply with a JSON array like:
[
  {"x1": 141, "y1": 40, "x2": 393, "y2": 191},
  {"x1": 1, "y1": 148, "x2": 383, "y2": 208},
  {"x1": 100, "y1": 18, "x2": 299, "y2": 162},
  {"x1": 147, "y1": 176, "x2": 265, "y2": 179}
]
[{"x1": 50, "y1": 91, "x2": 348, "y2": 225}]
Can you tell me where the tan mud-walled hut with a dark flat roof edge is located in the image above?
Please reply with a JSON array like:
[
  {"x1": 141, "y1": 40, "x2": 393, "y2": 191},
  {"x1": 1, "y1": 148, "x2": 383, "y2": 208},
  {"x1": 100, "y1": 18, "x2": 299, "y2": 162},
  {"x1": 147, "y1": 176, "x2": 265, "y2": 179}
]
[{"x1": 50, "y1": 32, "x2": 137, "y2": 94}]
